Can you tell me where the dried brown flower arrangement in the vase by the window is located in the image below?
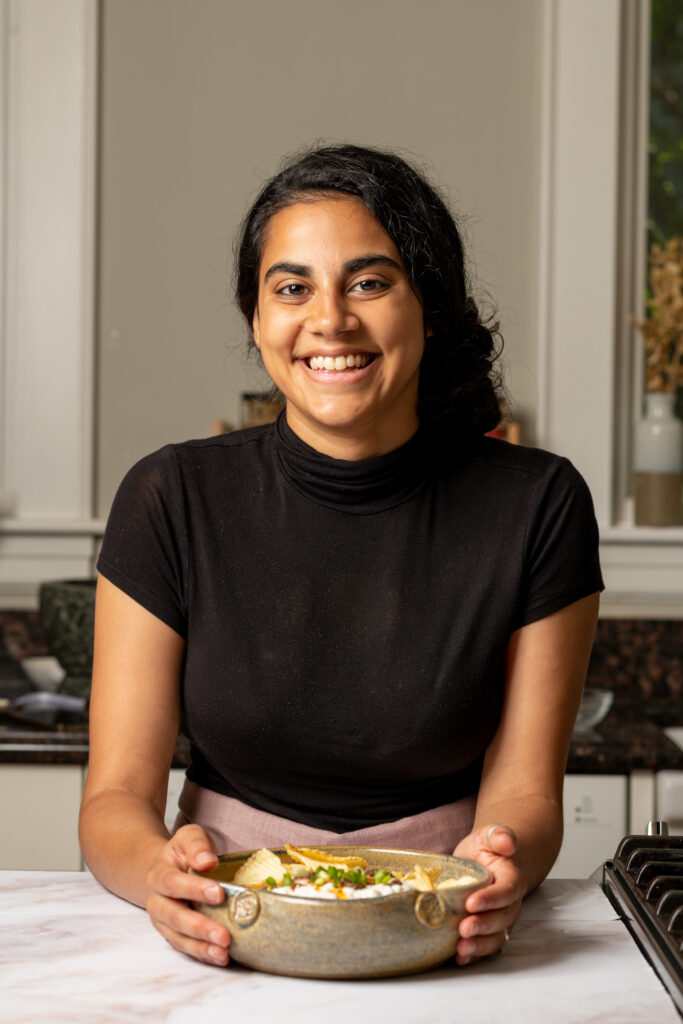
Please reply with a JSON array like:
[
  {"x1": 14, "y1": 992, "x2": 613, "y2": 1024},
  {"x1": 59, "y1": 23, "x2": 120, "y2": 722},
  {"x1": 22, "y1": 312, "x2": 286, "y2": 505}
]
[{"x1": 632, "y1": 236, "x2": 683, "y2": 391}]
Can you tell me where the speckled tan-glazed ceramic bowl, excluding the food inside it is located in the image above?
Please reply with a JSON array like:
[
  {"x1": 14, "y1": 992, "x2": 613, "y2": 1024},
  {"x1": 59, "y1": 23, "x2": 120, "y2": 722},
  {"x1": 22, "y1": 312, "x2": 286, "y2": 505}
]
[{"x1": 193, "y1": 846, "x2": 492, "y2": 978}]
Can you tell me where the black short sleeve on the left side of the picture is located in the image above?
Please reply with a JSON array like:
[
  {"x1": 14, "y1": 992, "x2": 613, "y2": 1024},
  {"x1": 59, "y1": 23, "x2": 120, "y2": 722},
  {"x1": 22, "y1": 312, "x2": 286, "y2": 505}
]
[{"x1": 97, "y1": 444, "x2": 187, "y2": 637}]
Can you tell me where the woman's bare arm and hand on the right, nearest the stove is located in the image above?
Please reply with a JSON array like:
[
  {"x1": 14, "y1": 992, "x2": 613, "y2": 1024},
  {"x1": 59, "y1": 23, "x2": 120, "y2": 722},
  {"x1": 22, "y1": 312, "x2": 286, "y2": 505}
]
[{"x1": 455, "y1": 594, "x2": 599, "y2": 964}]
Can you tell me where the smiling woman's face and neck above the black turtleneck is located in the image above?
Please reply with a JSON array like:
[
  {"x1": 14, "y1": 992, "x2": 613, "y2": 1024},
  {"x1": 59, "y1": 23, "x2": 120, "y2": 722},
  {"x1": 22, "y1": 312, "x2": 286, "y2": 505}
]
[{"x1": 253, "y1": 196, "x2": 424, "y2": 460}]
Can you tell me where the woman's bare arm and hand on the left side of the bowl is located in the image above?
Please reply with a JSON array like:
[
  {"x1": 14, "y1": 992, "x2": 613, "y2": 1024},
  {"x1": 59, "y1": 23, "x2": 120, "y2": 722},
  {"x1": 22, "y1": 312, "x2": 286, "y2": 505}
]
[{"x1": 79, "y1": 577, "x2": 229, "y2": 964}]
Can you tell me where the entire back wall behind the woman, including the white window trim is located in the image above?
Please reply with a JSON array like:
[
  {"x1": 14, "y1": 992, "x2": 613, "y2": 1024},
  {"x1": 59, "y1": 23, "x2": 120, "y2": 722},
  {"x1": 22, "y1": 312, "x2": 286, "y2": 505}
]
[{"x1": 6, "y1": 0, "x2": 671, "y2": 602}]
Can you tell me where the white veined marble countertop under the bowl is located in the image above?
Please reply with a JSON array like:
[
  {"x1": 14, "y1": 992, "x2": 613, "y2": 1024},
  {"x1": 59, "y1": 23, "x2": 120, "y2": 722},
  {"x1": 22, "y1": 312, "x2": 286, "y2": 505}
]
[{"x1": 0, "y1": 871, "x2": 680, "y2": 1024}]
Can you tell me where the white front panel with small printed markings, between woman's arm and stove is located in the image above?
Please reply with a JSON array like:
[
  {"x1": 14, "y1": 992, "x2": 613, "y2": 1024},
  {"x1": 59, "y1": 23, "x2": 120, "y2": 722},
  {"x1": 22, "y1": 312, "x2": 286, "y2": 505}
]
[{"x1": 549, "y1": 775, "x2": 628, "y2": 879}]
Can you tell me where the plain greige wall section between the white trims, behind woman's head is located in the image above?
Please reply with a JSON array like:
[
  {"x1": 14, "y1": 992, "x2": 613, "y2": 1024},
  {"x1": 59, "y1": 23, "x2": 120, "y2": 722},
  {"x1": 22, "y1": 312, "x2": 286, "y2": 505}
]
[{"x1": 95, "y1": 0, "x2": 543, "y2": 516}]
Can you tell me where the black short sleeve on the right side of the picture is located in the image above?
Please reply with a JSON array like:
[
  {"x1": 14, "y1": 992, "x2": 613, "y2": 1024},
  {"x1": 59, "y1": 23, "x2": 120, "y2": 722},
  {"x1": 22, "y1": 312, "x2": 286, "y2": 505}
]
[{"x1": 517, "y1": 459, "x2": 604, "y2": 627}]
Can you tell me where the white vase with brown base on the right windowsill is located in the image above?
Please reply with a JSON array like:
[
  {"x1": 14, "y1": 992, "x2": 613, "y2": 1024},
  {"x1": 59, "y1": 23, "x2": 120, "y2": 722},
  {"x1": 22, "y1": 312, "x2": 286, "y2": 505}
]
[{"x1": 634, "y1": 391, "x2": 683, "y2": 526}]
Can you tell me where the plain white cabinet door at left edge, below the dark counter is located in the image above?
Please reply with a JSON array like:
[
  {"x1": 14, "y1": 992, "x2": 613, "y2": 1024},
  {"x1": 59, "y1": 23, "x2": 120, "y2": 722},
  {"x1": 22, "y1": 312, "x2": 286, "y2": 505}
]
[{"x1": 0, "y1": 764, "x2": 83, "y2": 871}]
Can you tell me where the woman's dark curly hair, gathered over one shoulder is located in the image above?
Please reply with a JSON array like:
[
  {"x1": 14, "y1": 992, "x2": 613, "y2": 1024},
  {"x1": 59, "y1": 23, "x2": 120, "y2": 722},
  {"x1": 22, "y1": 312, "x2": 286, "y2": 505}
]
[{"x1": 236, "y1": 145, "x2": 502, "y2": 434}]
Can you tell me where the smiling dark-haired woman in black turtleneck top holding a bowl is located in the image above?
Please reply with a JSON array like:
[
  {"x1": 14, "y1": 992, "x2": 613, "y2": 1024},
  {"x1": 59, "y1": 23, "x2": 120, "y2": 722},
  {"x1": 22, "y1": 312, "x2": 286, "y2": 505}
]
[{"x1": 81, "y1": 145, "x2": 602, "y2": 965}]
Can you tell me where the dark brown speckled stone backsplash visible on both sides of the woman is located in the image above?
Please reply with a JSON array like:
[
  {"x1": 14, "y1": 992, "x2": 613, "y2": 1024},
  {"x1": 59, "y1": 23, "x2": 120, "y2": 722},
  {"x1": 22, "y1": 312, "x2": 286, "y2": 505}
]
[{"x1": 0, "y1": 611, "x2": 683, "y2": 718}]
